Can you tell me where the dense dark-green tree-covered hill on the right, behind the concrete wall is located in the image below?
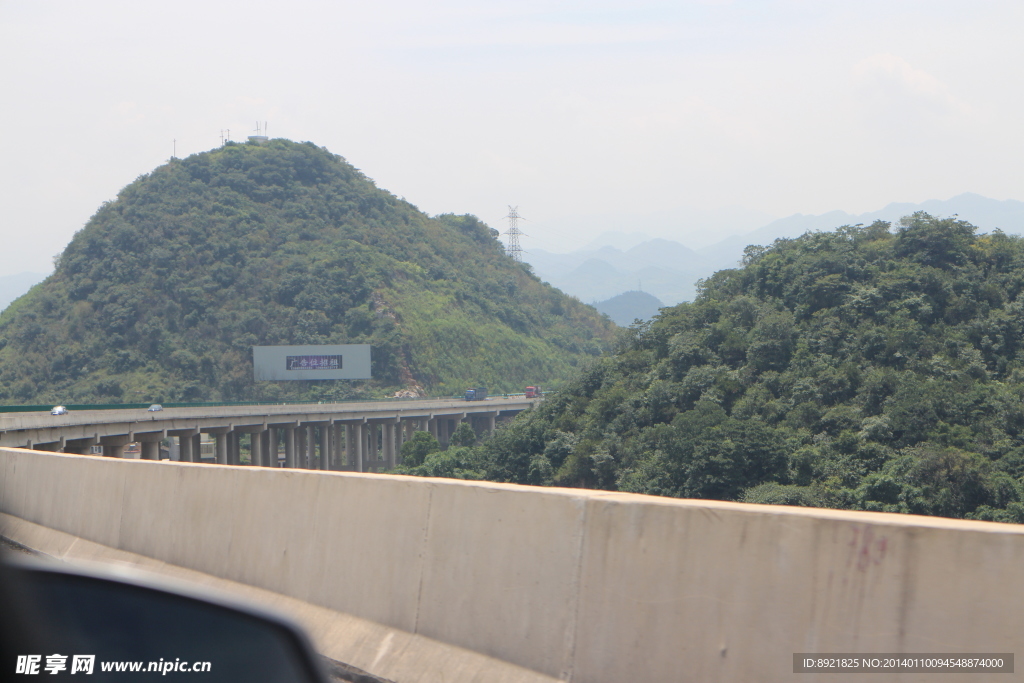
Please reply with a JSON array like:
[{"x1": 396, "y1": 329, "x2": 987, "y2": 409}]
[{"x1": 479, "y1": 214, "x2": 1024, "y2": 521}]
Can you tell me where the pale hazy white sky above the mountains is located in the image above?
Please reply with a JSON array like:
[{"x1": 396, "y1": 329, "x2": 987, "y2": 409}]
[{"x1": 0, "y1": 0, "x2": 1024, "y2": 274}]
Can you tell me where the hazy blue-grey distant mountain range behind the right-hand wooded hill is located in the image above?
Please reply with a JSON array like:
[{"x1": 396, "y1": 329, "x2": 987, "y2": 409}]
[{"x1": 524, "y1": 193, "x2": 1024, "y2": 309}]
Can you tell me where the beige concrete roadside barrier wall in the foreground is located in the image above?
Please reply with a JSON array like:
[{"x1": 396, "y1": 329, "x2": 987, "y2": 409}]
[{"x1": 0, "y1": 450, "x2": 1024, "y2": 683}]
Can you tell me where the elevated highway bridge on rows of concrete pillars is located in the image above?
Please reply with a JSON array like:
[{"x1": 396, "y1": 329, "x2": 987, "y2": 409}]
[{"x1": 0, "y1": 396, "x2": 539, "y2": 472}]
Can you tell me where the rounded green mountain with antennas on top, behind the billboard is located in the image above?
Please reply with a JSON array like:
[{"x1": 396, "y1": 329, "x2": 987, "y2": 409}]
[{"x1": 0, "y1": 139, "x2": 613, "y2": 403}]
